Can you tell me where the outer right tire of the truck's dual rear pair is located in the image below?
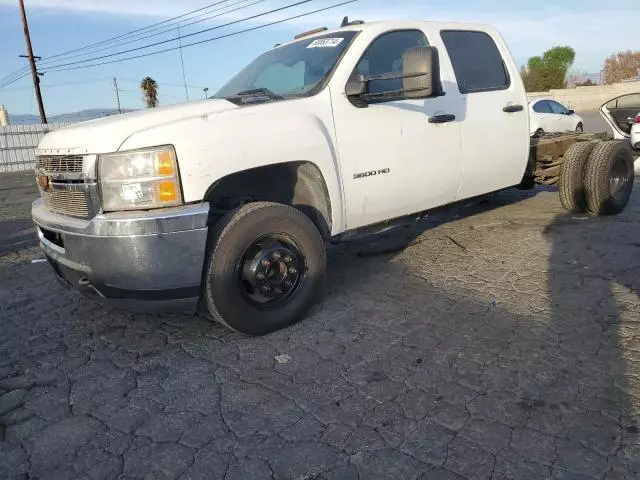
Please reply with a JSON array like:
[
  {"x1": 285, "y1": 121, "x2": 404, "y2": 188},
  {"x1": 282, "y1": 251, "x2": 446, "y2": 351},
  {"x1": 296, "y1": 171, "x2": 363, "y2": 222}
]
[{"x1": 584, "y1": 140, "x2": 634, "y2": 215}]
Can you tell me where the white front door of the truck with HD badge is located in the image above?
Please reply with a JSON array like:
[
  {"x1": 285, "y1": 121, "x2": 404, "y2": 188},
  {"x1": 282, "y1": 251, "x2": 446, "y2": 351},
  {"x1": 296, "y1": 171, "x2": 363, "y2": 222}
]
[{"x1": 331, "y1": 30, "x2": 463, "y2": 229}]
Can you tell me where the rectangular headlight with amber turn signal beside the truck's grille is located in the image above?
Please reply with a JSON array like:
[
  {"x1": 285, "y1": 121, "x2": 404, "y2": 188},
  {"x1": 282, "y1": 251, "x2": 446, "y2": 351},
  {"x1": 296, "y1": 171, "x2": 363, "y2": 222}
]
[{"x1": 98, "y1": 147, "x2": 182, "y2": 211}]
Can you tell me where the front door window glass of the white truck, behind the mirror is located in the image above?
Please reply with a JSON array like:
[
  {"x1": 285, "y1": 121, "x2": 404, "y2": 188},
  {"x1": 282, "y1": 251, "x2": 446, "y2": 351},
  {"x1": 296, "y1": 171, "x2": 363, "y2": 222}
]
[{"x1": 354, "y1": 30, "x2": 428, "y2": 97}]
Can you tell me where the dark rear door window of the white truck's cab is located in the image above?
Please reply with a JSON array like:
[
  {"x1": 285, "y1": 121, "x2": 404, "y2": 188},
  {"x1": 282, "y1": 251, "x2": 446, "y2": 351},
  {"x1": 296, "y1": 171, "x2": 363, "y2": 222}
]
[{"x1": 440, "y1": 30, "x2": 511, "y2": 94}]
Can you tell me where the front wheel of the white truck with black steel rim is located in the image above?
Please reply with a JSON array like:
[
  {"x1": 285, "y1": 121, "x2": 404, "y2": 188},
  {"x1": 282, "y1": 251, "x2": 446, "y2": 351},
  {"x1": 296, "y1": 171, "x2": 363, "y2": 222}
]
[{"x1": 202, "y1": 202, "x2": 326, "y2": 335}]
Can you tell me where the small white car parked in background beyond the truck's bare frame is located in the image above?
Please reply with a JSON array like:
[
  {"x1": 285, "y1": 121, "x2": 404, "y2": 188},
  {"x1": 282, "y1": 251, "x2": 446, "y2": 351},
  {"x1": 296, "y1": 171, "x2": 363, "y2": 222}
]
[{"x1": 529, "y1": 98, "x2": 584, "y2": 136}]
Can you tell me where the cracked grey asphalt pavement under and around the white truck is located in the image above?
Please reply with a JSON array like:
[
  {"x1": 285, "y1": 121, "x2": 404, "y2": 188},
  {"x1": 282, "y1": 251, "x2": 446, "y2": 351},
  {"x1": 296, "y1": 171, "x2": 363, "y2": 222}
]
[{"x1": 0, "y1": 173, "x2": 640, "y2": 480}]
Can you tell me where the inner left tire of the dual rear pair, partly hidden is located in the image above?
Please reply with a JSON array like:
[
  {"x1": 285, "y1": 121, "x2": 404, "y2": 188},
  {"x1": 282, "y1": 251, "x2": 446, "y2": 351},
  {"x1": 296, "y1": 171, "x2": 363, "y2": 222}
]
[{"x1": 558, "y1": 142, "x2": 598, "y2": 213}]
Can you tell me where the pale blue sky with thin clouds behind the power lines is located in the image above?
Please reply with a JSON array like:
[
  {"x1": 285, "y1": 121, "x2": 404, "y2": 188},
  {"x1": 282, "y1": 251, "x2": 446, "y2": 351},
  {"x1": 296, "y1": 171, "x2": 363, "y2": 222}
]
[{"x1": 0, "y1": 0, "x2": 640, "y2": 115}]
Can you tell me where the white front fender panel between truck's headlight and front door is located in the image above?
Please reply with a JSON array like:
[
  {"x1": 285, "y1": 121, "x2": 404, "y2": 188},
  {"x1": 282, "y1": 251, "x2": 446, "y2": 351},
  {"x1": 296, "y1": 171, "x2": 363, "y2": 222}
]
[{"x1": 120, "y1": 89, "x2": 345, "y2": 235}]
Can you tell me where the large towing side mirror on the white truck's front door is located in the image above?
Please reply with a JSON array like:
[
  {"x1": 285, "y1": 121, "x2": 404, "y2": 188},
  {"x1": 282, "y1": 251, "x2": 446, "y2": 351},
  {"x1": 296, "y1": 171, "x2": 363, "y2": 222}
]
[{"x1": 402, "y1": 47, "x2": 442, "y2": 98}]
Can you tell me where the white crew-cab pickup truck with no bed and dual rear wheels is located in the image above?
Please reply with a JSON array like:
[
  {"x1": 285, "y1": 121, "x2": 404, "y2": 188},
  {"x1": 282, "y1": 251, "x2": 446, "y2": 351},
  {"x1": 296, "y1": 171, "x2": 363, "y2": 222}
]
[{"x1": 32, "y1": 21, "x2": 633, "y2": 334}]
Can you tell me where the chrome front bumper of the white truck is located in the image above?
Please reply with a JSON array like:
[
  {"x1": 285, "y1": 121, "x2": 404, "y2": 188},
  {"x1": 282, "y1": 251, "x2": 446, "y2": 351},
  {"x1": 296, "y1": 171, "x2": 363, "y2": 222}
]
[{"x1": 31, "y1": 199, "x2": 209, "y2": 308}]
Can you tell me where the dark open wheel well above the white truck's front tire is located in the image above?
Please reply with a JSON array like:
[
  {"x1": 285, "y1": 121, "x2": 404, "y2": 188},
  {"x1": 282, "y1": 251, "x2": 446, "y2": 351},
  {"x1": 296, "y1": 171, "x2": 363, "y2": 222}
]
[{"x1": 204, "y1": 162, "x2": 331, "y2": 238}]
